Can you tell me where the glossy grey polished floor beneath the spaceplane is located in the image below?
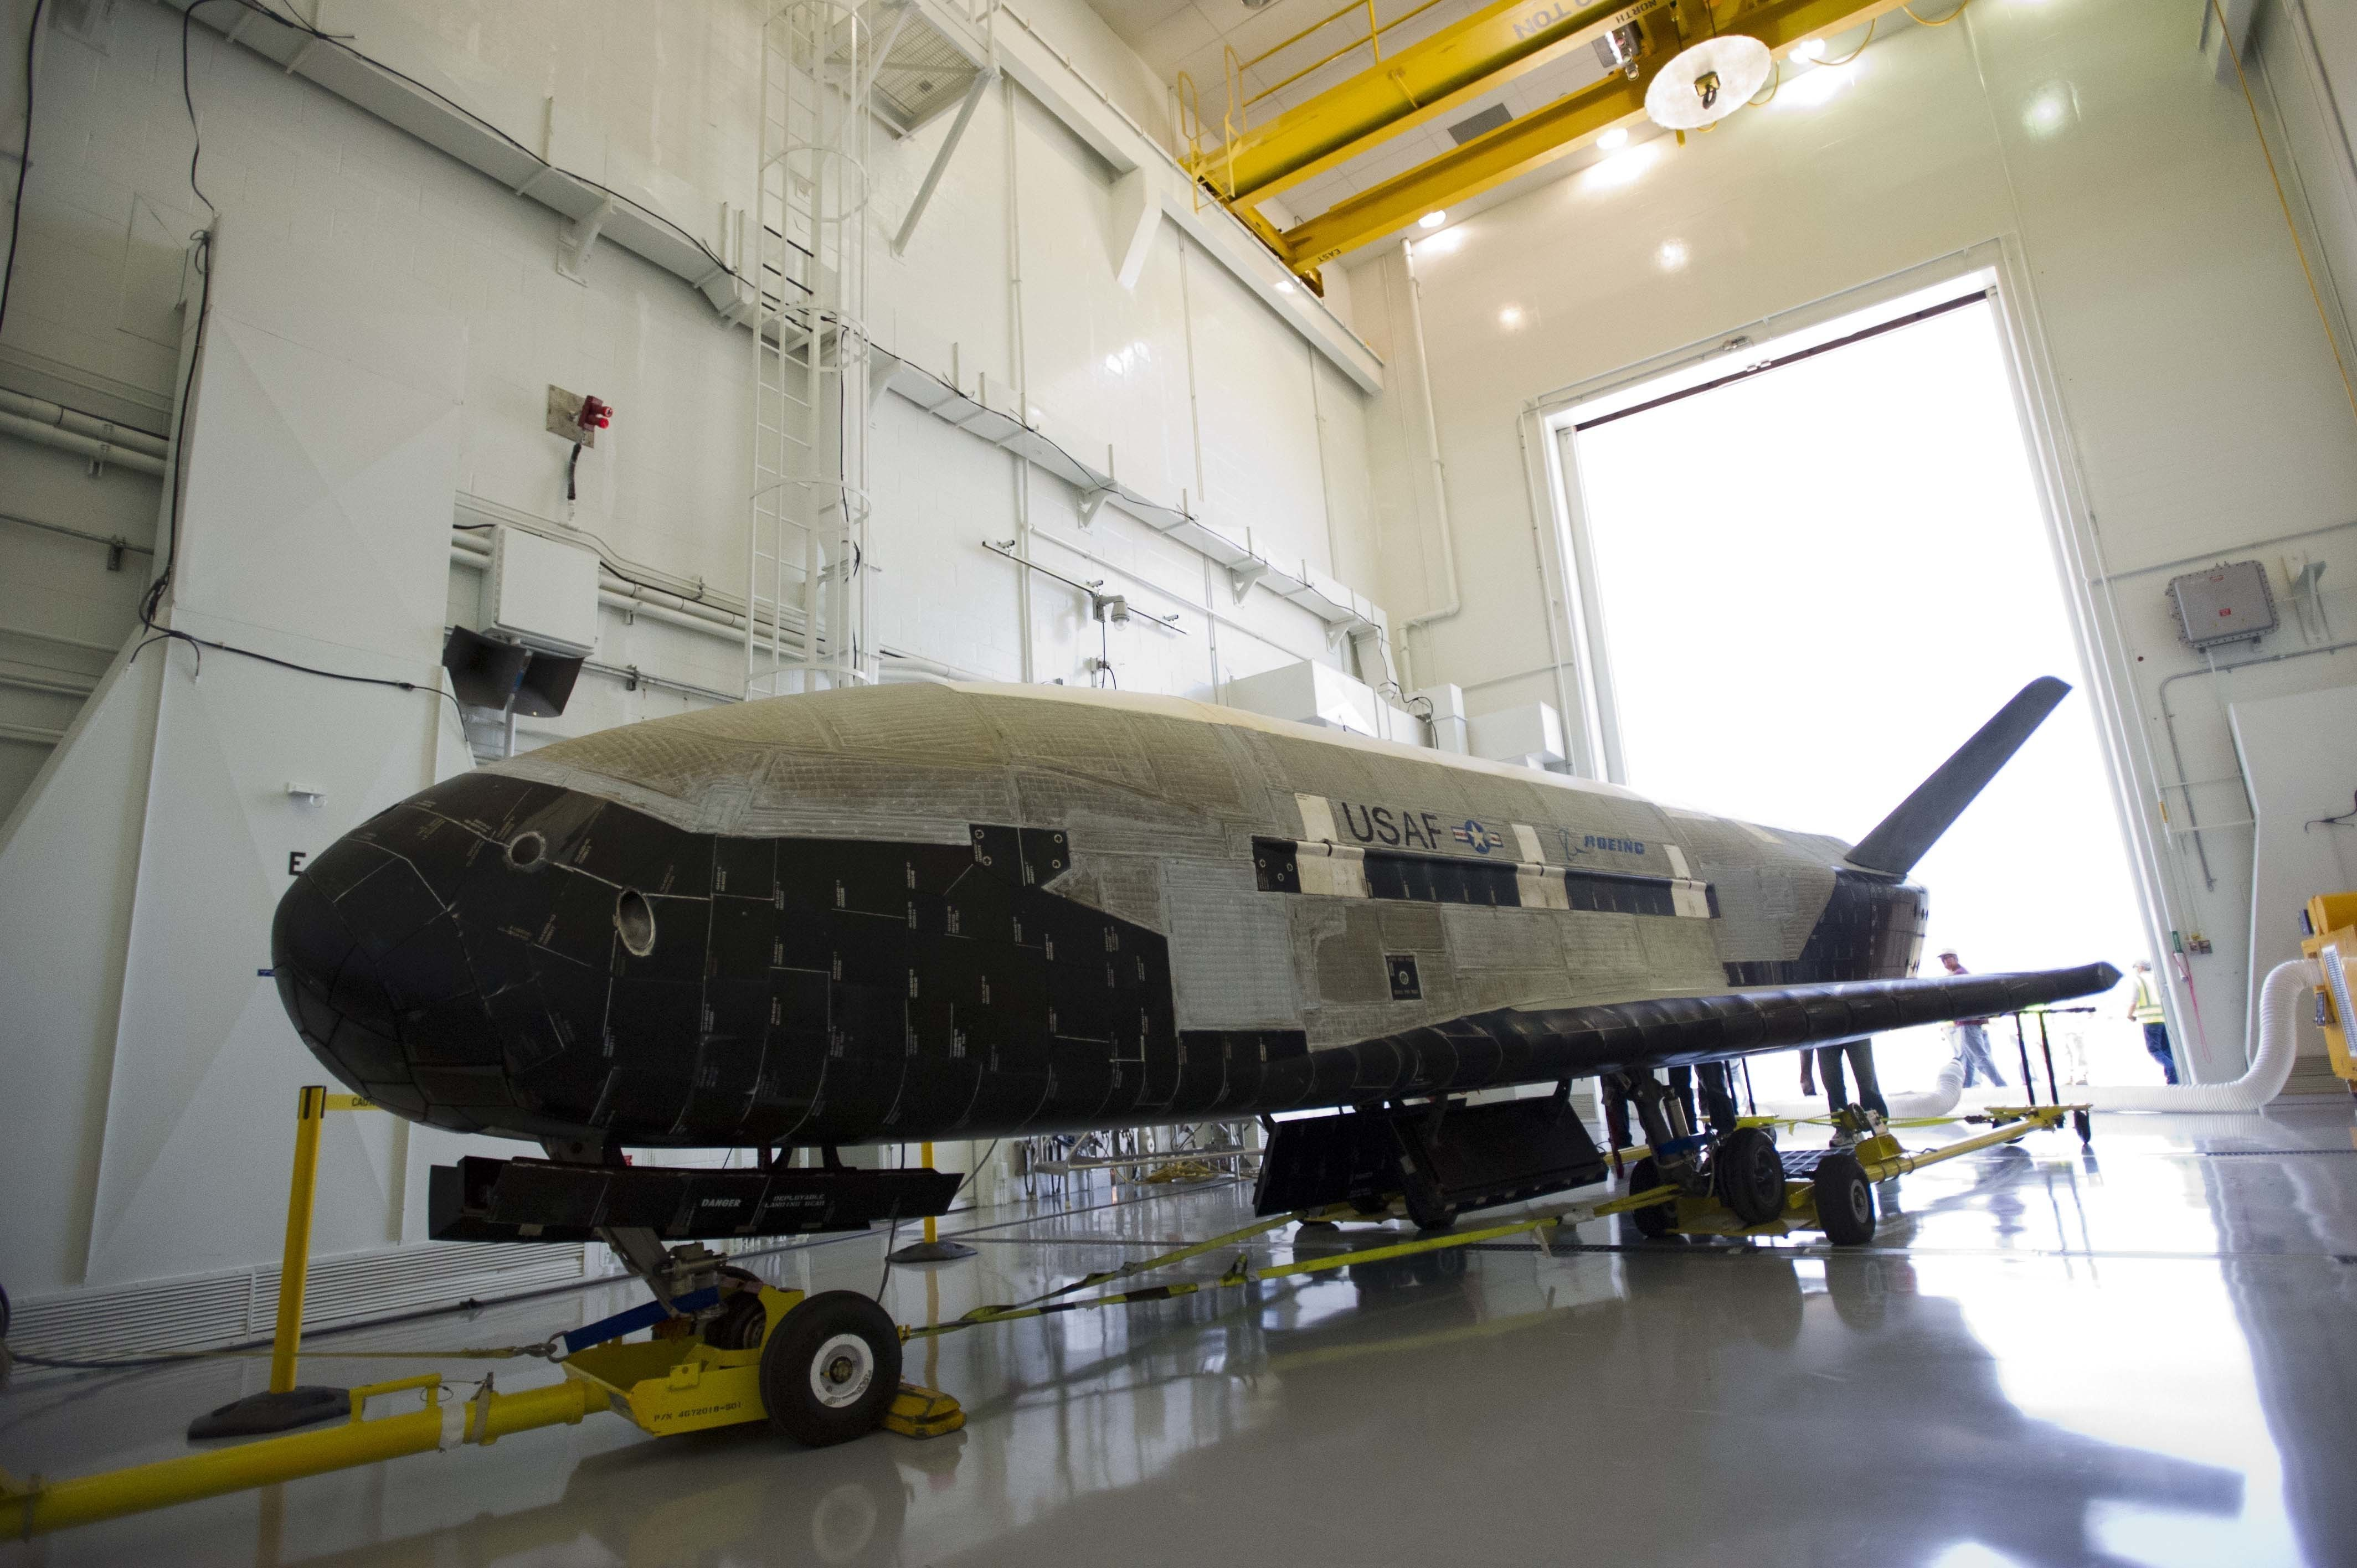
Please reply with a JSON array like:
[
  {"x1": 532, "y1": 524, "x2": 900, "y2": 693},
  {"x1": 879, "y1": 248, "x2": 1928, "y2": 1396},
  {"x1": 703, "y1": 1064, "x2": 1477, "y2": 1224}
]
[{"x1": 0, "y1": 1099, "x2": 2357, "y2": 1568}]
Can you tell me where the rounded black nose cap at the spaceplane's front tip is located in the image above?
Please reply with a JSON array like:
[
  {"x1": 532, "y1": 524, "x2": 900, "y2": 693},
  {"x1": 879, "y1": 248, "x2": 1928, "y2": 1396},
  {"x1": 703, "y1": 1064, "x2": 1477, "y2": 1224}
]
[{"x1": 271, "y1": 837, "x2": 481, "y2": 1118}]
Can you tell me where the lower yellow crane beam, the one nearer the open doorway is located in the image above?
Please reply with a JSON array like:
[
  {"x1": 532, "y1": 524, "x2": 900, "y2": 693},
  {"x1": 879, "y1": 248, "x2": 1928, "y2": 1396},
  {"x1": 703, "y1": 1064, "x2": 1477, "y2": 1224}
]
[{"x1": 1275, "y1": 0, "x2": 1902, "y2": 276}]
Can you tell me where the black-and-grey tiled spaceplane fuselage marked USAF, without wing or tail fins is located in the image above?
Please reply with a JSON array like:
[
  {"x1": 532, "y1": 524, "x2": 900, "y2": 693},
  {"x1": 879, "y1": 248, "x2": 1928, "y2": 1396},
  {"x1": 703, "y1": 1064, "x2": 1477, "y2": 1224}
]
[{"x1": 274, "y1": 686, "x2": 1923, "y2": 1146}]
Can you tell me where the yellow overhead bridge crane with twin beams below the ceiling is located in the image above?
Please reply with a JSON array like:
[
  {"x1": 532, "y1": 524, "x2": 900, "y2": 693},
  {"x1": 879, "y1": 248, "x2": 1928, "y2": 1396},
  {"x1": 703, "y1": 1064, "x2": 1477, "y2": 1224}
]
[{"x1": 1179, "y1": 0, "x2": 1905, "y2": 288}]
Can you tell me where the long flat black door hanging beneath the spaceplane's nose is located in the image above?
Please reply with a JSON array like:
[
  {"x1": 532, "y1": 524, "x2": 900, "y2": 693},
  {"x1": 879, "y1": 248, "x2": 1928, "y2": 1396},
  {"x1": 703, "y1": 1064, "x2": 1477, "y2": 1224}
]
[{"x1": 426, "y1": 1156, "x2": 961, "y2": 1242}]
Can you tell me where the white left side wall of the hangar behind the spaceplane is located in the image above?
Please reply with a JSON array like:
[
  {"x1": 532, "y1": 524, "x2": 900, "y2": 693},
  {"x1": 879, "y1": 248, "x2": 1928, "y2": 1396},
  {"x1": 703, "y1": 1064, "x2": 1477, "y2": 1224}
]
[{"x1": 0, "y1": 0, "x2": 1381, "y2": 1339}]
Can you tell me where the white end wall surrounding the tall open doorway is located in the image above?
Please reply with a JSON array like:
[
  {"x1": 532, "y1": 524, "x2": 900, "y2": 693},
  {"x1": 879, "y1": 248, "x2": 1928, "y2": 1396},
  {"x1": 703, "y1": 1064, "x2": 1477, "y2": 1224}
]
[{"x1": 1353, "y1": 0, "x2": 2357, "y2": 1080}]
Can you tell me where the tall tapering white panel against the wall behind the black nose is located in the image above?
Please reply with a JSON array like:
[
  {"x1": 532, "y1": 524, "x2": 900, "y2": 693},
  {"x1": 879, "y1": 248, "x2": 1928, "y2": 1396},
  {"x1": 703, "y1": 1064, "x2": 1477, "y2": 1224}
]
[{"x1": 87, "y1": 219, "x2": 464, "y2": 1283}]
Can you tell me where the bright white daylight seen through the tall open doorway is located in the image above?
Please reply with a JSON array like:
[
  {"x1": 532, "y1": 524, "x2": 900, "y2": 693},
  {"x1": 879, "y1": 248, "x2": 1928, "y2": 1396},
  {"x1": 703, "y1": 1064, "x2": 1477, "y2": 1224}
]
[{"x1": 1563, "y1": 281, "x2": 2157, "y2": 1096}]
